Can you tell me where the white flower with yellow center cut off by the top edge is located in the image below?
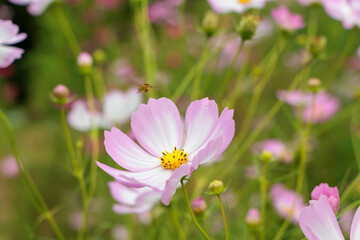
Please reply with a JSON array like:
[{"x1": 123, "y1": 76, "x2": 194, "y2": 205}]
[{"x1": 208, "y1": 0, "x2": 271, "y2": 13}]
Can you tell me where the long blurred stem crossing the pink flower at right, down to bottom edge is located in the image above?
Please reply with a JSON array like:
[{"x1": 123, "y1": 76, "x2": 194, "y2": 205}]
[{"x1": 274, "y1": 95, "x2": 316, "y2": 240}]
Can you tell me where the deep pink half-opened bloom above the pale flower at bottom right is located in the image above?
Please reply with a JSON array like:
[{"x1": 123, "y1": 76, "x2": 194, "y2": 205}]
[{"x1": 311, "y1": 183, "x2": 340, "y2": 213}]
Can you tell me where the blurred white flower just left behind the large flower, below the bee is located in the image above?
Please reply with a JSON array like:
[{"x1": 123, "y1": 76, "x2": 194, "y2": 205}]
[{"x1": 68, "y1": 88, "x2": 142, "y2": 132}]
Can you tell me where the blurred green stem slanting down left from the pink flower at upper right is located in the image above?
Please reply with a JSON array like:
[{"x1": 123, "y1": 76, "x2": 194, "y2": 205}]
[{"x1": 235, "y1": 37, "x2": 285, "y2": 142}]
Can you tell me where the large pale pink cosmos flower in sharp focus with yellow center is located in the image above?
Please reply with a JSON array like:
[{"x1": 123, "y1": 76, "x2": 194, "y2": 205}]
[{"x1": 97, "y1": 98, "x2": 235, "y2": 205}]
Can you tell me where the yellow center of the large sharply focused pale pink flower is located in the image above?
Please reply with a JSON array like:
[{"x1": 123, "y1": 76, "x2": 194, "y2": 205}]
[{"x1": 159, "y1": 147, "x2": 188, "y2": 171}]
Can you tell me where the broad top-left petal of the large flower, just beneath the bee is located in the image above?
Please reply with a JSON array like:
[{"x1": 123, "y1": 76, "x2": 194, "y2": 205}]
[{"x1": 131, "y1": 98, "x2": 183, "y2": 157}]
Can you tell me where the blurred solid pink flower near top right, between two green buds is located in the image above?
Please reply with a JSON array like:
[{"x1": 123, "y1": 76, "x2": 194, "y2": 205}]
[{"x1": 271, "y1": 6, "x2": 305, "y2": 31}]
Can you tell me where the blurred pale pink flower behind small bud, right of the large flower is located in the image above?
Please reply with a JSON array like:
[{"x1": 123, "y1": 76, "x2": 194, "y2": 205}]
[{"x1": 252, "y1": 139, "x2": 293, "y2": 163}]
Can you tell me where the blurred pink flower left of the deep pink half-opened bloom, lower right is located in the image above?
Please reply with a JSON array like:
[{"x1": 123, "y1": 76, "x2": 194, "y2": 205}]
[{"x1": 270, "y1": 184, "x2": 305, "y2": 224}]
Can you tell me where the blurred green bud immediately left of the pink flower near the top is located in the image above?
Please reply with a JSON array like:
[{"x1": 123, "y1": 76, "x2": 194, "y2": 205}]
[{"x1": 235, "y1": 15, "x2": 261, "y2": 41}]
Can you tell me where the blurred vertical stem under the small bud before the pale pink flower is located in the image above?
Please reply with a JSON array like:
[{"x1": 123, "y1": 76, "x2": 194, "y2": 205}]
[{"x1": 259, "y1": 162, "x2": 268, "y2": 240}]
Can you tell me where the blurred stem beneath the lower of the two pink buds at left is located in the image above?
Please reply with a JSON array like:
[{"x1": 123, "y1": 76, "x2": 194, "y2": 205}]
[{"x1": 60, "y1": 105, "x2": 89, "y2": 240}]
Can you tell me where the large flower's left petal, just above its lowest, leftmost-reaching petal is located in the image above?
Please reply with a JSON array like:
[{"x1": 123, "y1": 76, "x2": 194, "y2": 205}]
[{"x1": 104, "y1": 127, "x2": 161, "y2": 172}]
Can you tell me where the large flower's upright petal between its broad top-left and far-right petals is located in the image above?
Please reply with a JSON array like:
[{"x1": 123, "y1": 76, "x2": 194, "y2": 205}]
[{"x1": 184, "y1": 98, "x2": 219, "y2": 154}]
